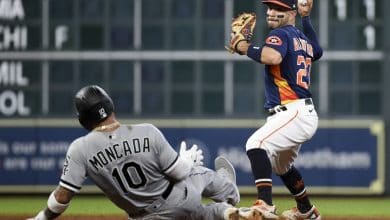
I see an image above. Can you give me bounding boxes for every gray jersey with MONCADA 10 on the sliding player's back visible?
[60,124,178,214]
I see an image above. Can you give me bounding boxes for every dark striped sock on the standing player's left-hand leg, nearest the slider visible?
[247,148,272,205]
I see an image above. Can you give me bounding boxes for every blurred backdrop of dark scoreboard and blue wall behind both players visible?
[0,0,390,195]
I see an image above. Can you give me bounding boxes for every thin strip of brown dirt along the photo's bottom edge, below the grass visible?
[0,215,390,220]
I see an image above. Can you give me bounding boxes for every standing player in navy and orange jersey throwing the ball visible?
[237,0,322,220]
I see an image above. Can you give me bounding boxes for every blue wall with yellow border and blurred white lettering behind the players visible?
[0,119,389,195]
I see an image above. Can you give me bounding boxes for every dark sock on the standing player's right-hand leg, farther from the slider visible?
[280,166,312,213]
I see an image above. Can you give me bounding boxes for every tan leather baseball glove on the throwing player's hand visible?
[225,13,256,55]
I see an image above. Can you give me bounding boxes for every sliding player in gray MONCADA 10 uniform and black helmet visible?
[31,85,256,220]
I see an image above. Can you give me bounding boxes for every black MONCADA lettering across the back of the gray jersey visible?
[88,138,150,170]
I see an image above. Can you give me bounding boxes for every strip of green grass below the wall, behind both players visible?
[0,195,390,218]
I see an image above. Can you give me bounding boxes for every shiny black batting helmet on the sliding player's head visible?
[74,85,114,131]
